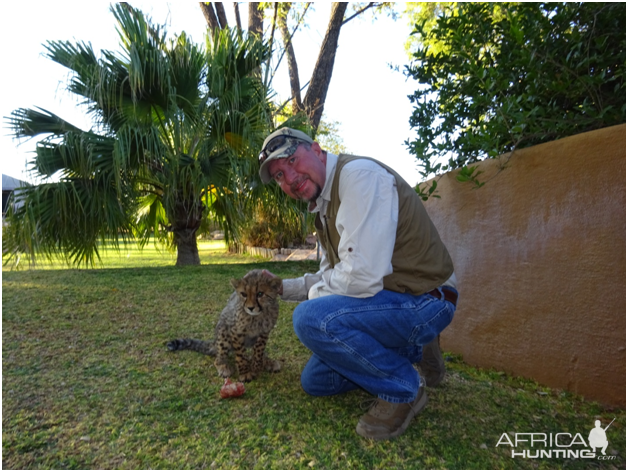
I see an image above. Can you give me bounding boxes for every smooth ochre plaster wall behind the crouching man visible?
[425,125,626,406]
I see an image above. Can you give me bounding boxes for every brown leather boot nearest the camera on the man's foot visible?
[355,387,427,440]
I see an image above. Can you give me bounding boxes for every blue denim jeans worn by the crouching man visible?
[292,290,455,403]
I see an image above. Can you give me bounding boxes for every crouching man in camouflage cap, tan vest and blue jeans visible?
[259,128,458,439]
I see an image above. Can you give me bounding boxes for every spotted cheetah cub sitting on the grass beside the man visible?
[167,270,282,382]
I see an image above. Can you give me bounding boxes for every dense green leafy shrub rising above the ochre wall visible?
[406,3,626,177]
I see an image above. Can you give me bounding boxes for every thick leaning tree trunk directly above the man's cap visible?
[303,2,348,130]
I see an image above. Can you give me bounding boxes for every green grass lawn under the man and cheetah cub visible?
[2,242,626,469]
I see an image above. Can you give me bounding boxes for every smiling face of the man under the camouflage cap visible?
[268,142,327,202]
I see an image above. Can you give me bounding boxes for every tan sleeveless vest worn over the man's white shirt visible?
[315,154,454,295]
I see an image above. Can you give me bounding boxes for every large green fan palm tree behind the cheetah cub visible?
[3,4,271,265]
